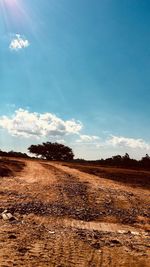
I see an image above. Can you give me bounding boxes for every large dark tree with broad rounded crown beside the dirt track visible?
[28,142,74,161]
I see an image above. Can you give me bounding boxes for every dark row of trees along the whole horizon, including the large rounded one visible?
[0,142,150,169]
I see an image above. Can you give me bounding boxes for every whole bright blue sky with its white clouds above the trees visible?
[0,0,150,159]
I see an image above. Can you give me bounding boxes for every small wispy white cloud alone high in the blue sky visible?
[9,34,30,51]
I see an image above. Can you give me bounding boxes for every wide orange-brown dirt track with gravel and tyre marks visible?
[0,160,150,267]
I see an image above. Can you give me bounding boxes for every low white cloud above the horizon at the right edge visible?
[106,135,150,150]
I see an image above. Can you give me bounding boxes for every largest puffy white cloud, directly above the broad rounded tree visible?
[0,109,82,137]
